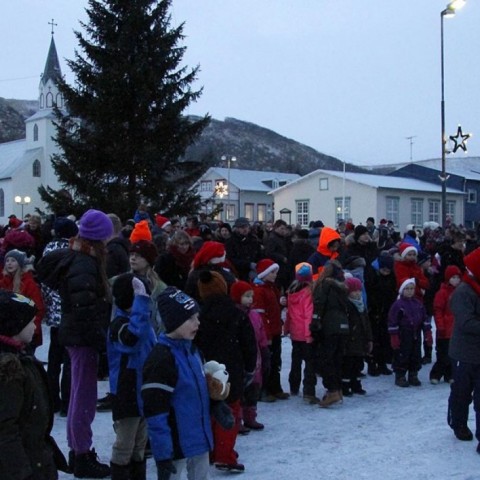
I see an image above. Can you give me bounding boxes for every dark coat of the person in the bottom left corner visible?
[0,341,66,480]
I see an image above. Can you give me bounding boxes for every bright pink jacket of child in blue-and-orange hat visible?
[283,287,313,343]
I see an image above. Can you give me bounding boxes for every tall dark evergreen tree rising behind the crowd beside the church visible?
[40,0,210,219]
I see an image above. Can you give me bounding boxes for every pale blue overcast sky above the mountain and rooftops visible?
[0,0,480,165]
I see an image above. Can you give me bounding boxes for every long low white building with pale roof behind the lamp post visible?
[270,170,465,229]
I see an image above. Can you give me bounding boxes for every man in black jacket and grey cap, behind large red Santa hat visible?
[225,217,262,282]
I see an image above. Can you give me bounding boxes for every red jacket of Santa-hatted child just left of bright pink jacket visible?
[252,282,282,342]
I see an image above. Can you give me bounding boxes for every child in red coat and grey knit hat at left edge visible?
[0,250,45,354]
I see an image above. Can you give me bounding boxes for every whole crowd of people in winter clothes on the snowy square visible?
[0,205,480,480]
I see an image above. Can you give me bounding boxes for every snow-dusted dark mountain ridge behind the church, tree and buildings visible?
[0,97,365,175]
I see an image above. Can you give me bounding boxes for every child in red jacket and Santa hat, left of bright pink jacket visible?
[253,258,290,402]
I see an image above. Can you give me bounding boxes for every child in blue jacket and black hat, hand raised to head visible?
[107,273,156,480]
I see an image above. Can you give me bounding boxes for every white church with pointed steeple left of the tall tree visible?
[0,35,63,225]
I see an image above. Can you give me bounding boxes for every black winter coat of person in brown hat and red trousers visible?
[195,295,257,403]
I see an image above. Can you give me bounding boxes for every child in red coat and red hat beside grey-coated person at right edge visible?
[430,265,462,385]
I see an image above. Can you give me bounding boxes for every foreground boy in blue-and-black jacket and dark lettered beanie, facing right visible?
[142,287,213,480]
